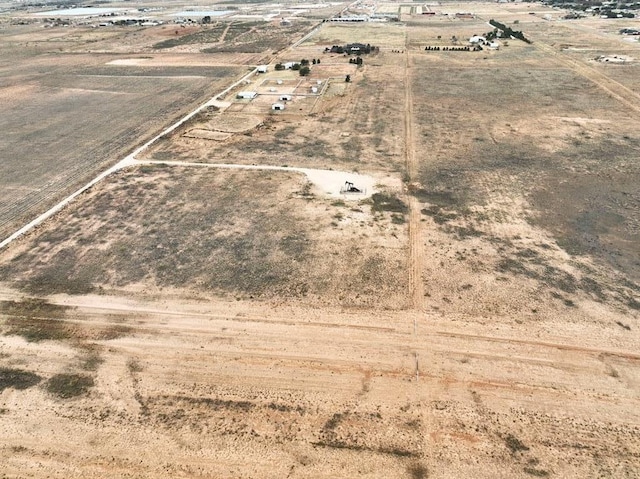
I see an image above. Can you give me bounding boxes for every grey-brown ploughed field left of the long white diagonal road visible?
[0,21,248,239]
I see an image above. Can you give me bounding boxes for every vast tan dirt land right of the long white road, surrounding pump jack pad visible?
[0,3,640,479]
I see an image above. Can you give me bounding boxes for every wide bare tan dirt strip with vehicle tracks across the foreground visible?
[0,289,640,478]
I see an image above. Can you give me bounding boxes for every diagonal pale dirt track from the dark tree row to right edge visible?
[533,40,640,113]
